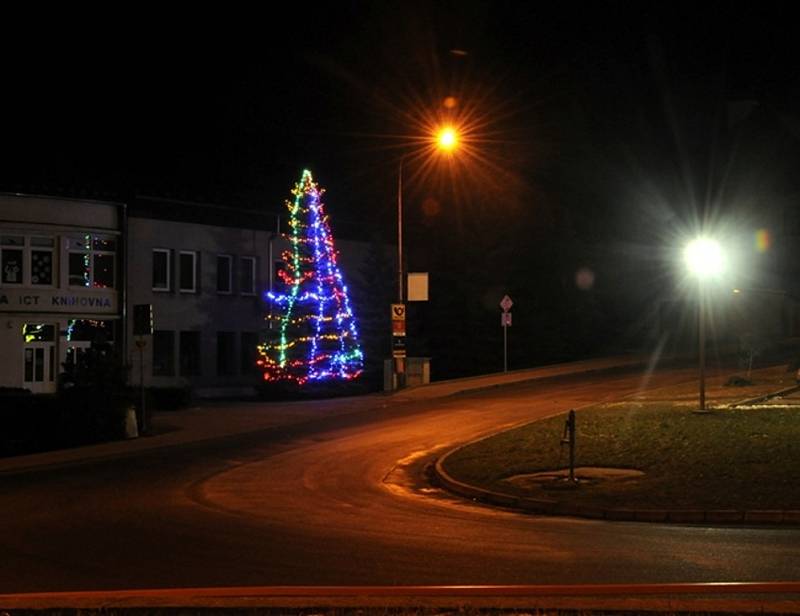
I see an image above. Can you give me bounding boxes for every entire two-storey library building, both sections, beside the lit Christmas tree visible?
[0,194,366,396]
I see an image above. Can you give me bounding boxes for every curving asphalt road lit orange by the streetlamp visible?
[0,370,800,593]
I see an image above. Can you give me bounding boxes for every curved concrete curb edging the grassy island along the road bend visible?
[433,437,800,526]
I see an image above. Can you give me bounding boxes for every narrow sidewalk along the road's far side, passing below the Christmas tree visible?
[0,356,645,475]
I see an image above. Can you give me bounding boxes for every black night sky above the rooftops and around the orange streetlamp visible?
[0,1,797,236]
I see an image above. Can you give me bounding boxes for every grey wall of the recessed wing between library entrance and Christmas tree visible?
[127,217,281,395]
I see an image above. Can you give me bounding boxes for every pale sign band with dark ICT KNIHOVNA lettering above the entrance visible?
[0,289,119,314]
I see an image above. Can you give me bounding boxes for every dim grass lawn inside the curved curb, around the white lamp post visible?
[445,367,800,510]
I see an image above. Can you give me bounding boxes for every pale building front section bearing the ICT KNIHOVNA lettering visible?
[0,194,125,393]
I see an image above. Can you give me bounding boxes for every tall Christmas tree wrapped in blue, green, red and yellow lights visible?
[256,170,364,385]
